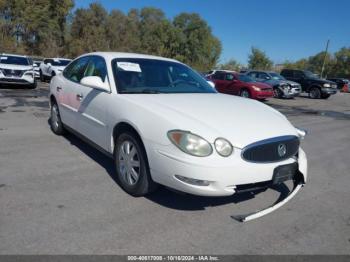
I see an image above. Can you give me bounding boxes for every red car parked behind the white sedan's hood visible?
[207,71,273,100]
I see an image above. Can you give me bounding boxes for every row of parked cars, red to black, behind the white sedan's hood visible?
[204,69,350,100]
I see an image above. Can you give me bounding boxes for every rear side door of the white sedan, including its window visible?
[57,57,89,130]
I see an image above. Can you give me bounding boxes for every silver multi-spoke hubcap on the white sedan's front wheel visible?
[118,140,140,186]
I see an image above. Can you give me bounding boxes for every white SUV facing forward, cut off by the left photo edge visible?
[0,54,36,88]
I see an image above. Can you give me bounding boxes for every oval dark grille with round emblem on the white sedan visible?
[242,136,300,163]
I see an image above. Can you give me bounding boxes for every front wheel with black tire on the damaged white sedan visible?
[114,132,157,197]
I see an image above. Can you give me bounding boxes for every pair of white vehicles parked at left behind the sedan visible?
[0,53,71,88]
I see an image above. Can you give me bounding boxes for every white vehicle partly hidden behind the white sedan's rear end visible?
[39,58,72,82]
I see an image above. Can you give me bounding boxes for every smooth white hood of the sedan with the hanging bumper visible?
[123,93,297,148]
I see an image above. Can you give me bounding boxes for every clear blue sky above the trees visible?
[75,0,350,64]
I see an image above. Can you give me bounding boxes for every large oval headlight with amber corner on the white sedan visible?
[168,130,213,157]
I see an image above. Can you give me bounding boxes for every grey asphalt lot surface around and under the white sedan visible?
[0,84,350,254]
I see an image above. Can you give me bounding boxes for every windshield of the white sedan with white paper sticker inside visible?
[112,58,216,94]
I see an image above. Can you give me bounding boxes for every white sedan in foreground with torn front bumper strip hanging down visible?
[50,52,307,221]
